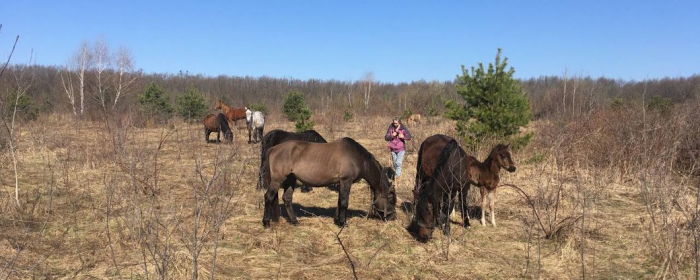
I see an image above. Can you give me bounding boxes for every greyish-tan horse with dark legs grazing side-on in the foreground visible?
[263,138,396,227]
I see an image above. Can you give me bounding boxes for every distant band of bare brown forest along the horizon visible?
[0,65,700,123]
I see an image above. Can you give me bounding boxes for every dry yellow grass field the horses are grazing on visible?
[0,112,693,279]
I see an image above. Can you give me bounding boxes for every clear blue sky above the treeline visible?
[0,0,700,83]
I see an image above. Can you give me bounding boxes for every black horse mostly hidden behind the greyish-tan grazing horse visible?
[258,129,328,192]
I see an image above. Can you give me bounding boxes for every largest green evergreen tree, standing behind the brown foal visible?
[446,49,532,147]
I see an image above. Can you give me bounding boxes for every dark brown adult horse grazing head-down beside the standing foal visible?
[409,135,473,242]
